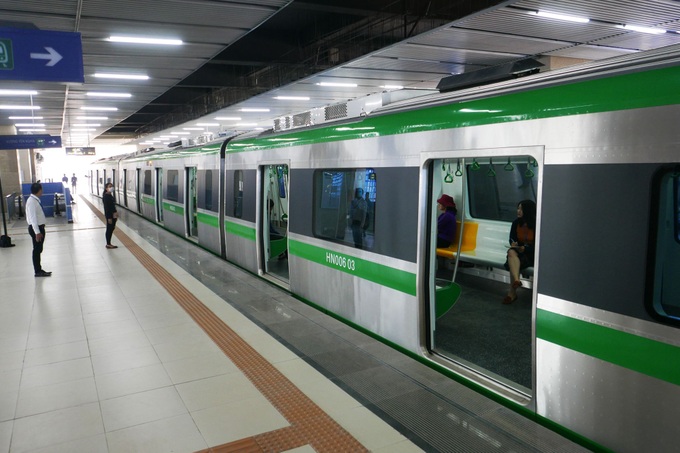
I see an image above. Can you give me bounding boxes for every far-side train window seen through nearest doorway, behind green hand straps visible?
[466,158,538,222]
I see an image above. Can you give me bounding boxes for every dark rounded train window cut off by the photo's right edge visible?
[652,171,680,321]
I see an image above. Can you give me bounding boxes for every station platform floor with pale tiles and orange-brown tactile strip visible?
[0,196,587,453]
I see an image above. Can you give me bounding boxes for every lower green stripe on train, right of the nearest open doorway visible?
[536,309,680,385]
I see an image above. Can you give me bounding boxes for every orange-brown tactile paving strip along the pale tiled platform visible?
[81,197,368,453]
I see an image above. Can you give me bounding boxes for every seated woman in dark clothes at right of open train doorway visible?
[503,200,536,304]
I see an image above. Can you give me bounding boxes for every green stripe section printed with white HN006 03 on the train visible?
[288,240,416,296]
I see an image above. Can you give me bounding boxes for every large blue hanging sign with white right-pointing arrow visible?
[0,27,85,83]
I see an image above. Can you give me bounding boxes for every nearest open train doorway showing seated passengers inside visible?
[426,148,542,401]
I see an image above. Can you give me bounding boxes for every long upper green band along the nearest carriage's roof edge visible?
[227,66,680,152]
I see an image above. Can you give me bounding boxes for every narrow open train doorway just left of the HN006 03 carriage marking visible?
[259,164,289,283]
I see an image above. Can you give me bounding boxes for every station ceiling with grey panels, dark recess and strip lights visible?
[0,0,680,146]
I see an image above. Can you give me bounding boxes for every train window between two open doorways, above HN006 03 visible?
[313,168,376,250]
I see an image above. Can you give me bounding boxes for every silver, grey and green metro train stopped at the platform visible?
[90,47,680,452]
